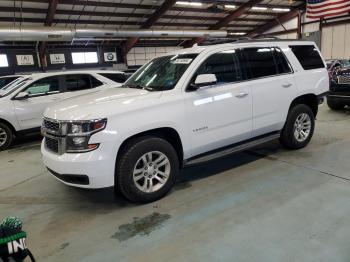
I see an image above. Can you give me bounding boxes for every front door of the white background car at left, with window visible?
[13,76,62,130]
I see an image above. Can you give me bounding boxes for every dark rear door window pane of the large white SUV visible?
[242,47,278,78]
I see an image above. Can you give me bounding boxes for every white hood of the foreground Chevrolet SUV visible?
[44,87,161,120]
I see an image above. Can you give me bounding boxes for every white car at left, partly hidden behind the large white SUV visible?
[0,70,126,151]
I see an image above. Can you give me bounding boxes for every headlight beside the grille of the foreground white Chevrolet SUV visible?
[66,119,107,153]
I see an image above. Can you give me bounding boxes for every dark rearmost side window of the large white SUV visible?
[289,45,325,70]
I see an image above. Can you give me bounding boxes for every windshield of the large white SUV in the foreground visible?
[124,54,197,91]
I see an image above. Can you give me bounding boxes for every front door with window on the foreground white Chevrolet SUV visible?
[184,50,252,156]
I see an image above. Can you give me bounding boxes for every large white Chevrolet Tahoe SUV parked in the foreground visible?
[41,40,329,202]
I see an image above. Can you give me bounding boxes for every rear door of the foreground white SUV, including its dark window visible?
[242,47,297,137]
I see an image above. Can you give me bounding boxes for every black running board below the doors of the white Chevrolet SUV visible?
[184,133,280,166]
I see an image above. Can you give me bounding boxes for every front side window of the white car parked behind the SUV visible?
[24,76,59,96]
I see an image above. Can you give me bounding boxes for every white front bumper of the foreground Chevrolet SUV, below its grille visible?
[41,136,117,189]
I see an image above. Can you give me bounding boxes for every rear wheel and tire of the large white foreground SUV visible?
[280,104,315,149]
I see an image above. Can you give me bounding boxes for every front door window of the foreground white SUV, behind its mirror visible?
[193,50,243,84]
